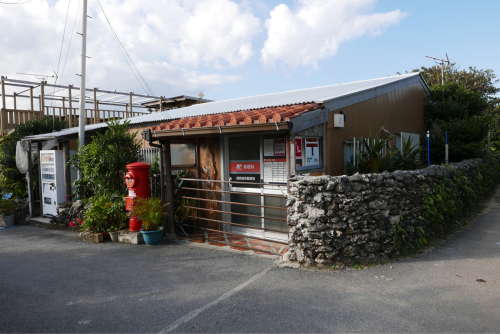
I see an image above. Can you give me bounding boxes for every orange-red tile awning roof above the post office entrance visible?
[150,103,322,131]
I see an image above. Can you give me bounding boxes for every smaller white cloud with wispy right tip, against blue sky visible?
[261,0,406,70]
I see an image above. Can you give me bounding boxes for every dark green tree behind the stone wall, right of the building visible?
[414,64,500,163]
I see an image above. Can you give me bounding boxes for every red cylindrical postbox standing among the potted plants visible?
[125,162,151,231]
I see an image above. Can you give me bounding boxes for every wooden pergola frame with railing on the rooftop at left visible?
[0,76,166,136]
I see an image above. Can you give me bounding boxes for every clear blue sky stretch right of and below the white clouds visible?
[219,0,500,99]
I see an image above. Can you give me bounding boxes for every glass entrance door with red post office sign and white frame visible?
[225,135,288,240]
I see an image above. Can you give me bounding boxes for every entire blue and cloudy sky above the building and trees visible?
[0,0,500,105]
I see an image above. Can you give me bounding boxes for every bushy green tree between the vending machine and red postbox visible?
[69,121,140,197]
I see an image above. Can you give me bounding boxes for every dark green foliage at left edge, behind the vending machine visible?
[0,116,68,197]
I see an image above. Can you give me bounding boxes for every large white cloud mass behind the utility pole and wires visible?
[0,0,261,98]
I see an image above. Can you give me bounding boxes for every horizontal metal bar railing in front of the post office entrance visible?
[177,178,288,255]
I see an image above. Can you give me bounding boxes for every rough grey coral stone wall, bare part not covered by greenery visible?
[287,159,483,265]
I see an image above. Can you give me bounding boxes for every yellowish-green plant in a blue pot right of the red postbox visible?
[131,197,168,245]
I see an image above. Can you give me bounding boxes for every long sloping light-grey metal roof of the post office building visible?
[21,72,428,139]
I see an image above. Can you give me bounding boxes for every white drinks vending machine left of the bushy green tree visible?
[40,150,76,216]
